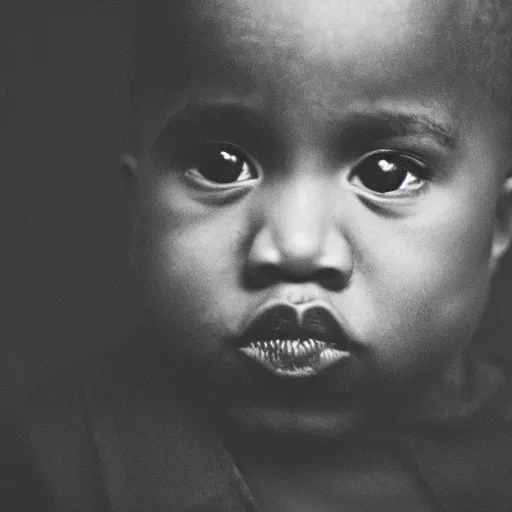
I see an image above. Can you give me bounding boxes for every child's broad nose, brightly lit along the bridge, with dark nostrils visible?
[248,175,353,289]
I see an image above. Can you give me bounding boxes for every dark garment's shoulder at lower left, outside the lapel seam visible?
[0,346,169,511]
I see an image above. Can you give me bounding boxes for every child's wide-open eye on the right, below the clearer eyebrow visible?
[349,151,428,196]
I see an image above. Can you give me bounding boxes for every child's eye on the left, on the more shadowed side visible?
[186,141,259,186]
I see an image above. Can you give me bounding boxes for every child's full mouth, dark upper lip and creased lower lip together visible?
[236,302,358,378]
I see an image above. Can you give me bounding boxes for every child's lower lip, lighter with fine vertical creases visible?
[239,339,350,378]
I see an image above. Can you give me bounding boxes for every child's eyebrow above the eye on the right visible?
[340,110,460,150]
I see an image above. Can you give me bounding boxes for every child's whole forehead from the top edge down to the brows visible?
[136,0,480,142]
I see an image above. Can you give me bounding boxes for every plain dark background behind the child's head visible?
[4,0,512,398]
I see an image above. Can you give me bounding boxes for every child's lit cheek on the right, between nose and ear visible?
[352,186,493,372]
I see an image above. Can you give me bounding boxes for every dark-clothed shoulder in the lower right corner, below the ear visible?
[405,387,512,512]
